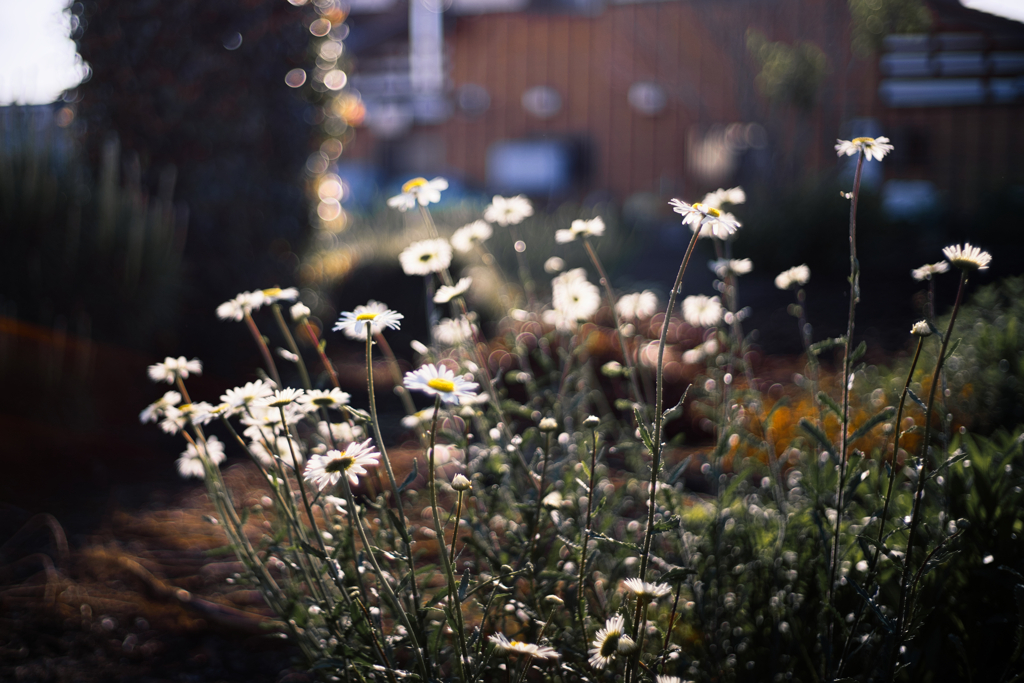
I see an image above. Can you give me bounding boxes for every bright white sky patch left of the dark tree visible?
[0,0,84,104]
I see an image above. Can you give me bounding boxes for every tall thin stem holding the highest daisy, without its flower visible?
[822,151,864,675]
